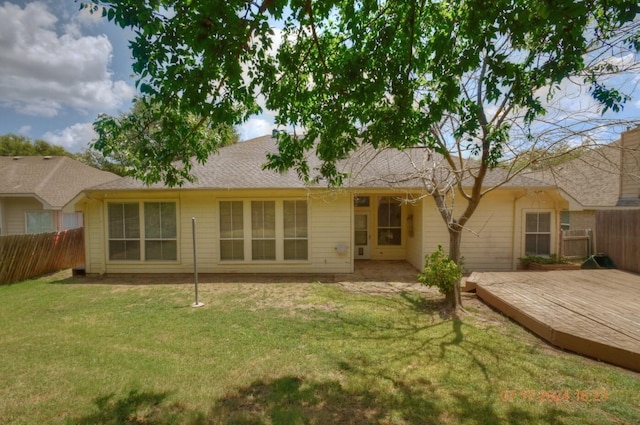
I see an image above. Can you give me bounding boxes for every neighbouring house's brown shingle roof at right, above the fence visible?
[527,142,621,209]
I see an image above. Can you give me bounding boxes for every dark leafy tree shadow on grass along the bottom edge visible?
[67,374,567,425]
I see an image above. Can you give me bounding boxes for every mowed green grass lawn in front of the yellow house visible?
[0,272,640,425]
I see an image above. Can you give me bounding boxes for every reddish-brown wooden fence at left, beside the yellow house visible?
[0,228,84,284]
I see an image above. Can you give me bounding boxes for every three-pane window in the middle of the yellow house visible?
[219,200,309,261]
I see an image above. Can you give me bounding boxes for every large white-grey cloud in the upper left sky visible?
[0,2,135,117]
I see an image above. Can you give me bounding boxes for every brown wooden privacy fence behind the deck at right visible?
[596,210,640,273]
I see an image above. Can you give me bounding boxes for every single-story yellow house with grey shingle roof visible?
[72,136,570,274]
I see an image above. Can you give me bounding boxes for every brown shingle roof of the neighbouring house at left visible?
[0,156,120,209]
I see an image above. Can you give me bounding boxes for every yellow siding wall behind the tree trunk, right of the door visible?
[423,190,566,273]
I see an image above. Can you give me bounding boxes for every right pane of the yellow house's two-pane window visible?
[144,202,178,261]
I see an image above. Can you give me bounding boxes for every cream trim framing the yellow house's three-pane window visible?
[216,197,312,265]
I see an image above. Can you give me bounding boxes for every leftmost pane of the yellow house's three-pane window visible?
[220,201,244,260]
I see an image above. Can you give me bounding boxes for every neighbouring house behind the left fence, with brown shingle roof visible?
[0,156,119,235]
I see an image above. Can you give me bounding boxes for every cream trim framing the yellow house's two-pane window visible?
[104,198,182,265]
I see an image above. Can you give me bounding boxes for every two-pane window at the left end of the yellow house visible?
[107,202,178,261]
